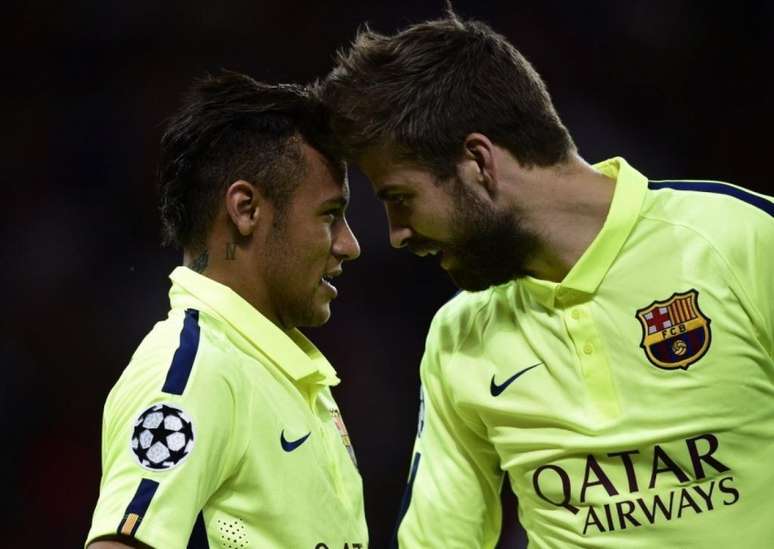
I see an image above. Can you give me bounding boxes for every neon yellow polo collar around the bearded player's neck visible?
[524,157,648,308]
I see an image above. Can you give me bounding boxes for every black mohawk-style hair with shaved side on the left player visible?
[159,71,341,249]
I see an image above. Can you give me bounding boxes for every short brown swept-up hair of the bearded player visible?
[319,13,575,178]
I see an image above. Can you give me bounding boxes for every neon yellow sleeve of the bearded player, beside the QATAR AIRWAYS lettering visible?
[397,317,503,549]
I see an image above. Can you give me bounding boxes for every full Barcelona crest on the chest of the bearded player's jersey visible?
[637,289,712,370]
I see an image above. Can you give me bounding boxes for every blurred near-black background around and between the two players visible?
[0,0,774,548]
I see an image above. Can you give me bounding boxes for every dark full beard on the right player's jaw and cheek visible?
[444,178,537,292]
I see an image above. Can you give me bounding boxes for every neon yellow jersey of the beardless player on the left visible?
[87,267,368,549]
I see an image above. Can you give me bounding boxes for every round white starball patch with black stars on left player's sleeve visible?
[130,404,194,471]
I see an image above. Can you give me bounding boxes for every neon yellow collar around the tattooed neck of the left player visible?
[169,267,340,385]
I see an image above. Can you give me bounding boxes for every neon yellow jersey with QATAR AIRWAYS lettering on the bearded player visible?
[398,158,774,549]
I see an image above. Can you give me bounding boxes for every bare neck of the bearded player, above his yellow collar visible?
[519,155,615,282]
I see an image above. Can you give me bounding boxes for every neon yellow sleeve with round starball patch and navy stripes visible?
[87,317,249,549]
